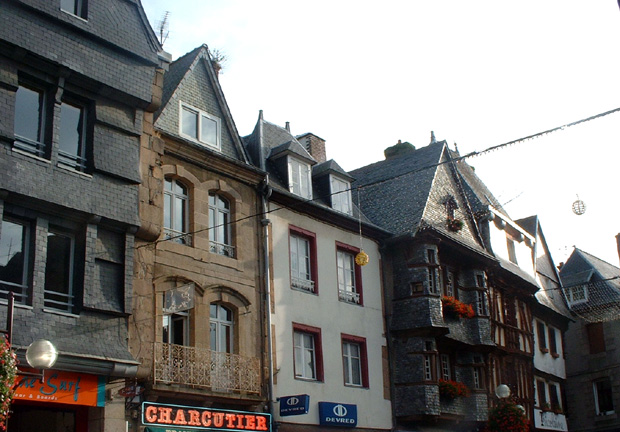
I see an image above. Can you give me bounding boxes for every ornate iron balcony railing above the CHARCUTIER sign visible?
[153,342,261,394]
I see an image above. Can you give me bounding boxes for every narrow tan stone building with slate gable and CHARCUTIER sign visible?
[127,45,271,430]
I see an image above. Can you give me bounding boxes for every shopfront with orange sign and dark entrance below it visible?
[8,370,105,432]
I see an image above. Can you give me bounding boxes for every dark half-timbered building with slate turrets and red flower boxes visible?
[349,137,538,431]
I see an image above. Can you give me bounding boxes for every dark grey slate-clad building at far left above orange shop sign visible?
[0,0,163,431]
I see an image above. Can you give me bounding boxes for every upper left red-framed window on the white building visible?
[289,225,319,294]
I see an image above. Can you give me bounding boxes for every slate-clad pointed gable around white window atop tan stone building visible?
[155,45,249,163]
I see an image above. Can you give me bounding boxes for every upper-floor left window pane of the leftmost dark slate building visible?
[15,86,43,141]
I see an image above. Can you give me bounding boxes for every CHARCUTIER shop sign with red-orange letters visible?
[142,402,271,432]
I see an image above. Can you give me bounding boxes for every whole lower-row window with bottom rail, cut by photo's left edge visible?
[0,217,31,304]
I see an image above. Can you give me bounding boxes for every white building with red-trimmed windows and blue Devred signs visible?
[244,112,392,432]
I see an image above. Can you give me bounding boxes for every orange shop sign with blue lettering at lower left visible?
[13,370,105,407]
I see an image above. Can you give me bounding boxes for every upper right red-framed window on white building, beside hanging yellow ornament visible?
[336,242,364,305]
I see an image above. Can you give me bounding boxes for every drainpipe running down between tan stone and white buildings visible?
[261,174,277,430]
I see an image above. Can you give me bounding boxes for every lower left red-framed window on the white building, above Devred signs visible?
[293,323,323,381]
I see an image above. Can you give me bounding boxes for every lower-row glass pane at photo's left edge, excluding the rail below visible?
[0,219,28,285]
